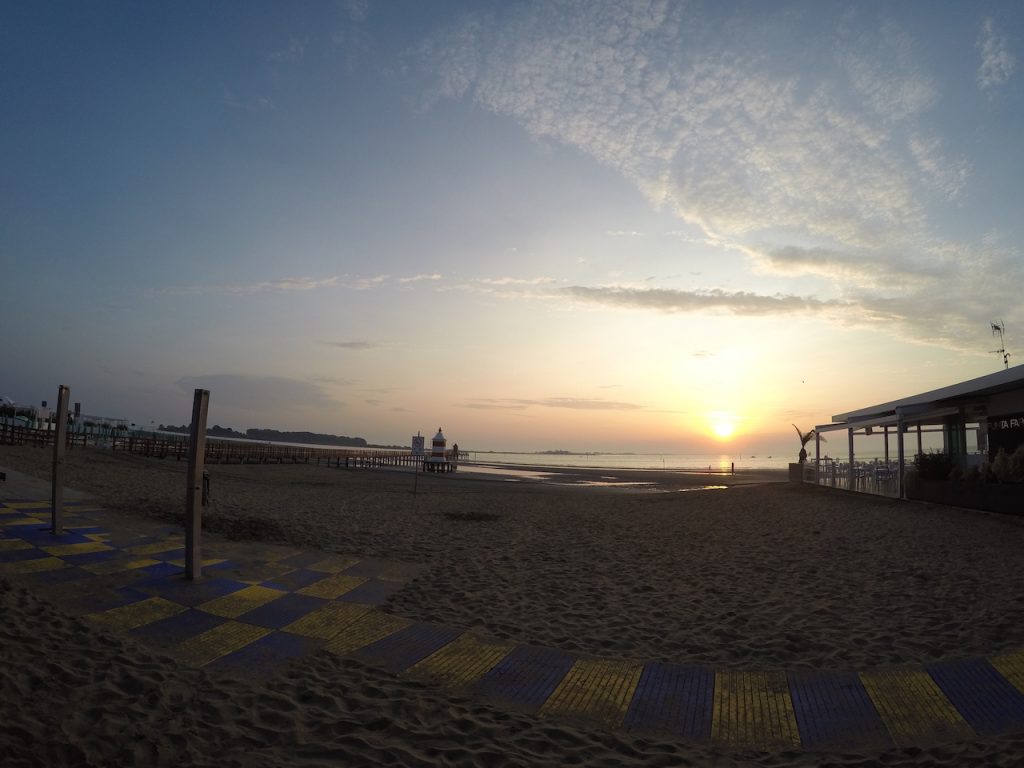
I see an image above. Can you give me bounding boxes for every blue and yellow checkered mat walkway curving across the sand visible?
[6,501,1024,752]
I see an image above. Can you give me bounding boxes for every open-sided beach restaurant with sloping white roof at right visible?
[803,366,1024,512]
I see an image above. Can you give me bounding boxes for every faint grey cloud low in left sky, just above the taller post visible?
[175,374,341,414]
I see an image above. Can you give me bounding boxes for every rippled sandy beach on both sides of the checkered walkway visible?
[6,446,1024,766]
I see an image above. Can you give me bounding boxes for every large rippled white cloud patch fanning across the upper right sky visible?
[417,2,936,245]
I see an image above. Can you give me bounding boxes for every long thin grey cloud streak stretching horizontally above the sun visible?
[562,286,844,315]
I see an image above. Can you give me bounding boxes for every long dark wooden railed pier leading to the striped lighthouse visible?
[0,424,465,472]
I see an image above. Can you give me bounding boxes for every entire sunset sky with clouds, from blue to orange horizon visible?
[0,0,1024,454]
